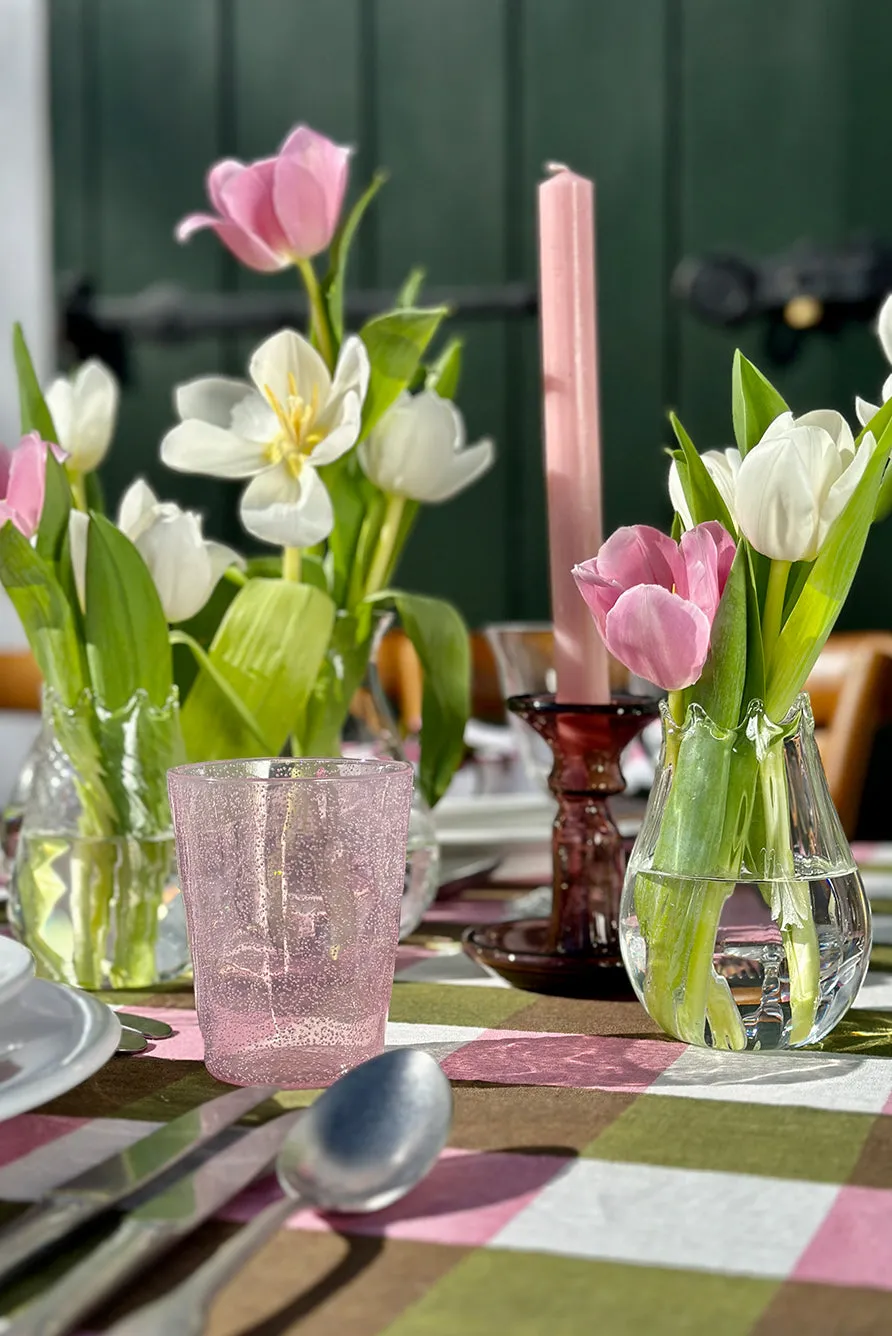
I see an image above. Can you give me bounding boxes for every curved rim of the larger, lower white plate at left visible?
[0,978,122,1124]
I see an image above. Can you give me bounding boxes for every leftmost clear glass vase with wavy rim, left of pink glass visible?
[9,688,190,989]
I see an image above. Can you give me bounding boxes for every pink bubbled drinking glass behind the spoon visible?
[167,759,413,1089]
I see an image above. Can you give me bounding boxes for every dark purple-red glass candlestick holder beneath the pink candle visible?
[463,695,658,998]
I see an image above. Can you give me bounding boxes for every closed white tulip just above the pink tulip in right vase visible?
[734,410,876,561]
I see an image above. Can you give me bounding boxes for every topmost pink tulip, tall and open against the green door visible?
[176,126,351,274]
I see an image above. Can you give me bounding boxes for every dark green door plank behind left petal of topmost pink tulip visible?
[89,0,224,521]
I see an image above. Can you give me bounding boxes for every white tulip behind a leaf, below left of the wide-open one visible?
[68,478,244,621]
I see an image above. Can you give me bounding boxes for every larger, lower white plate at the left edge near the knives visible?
[0,979,120,1120]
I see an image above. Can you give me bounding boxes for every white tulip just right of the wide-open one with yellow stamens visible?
[359,390,495,502]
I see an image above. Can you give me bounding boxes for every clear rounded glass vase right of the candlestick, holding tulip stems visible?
[620,695,871,1051]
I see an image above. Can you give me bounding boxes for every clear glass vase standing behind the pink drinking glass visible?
[304,609,439,939]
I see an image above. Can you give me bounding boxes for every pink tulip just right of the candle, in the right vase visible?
[573,521,736,691]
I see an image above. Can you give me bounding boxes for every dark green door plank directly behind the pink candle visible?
[523,0,668,616]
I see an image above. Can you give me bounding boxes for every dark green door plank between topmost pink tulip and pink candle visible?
[375,0,507,623]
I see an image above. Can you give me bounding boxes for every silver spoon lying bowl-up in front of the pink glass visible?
[105,1049,453,1336]
